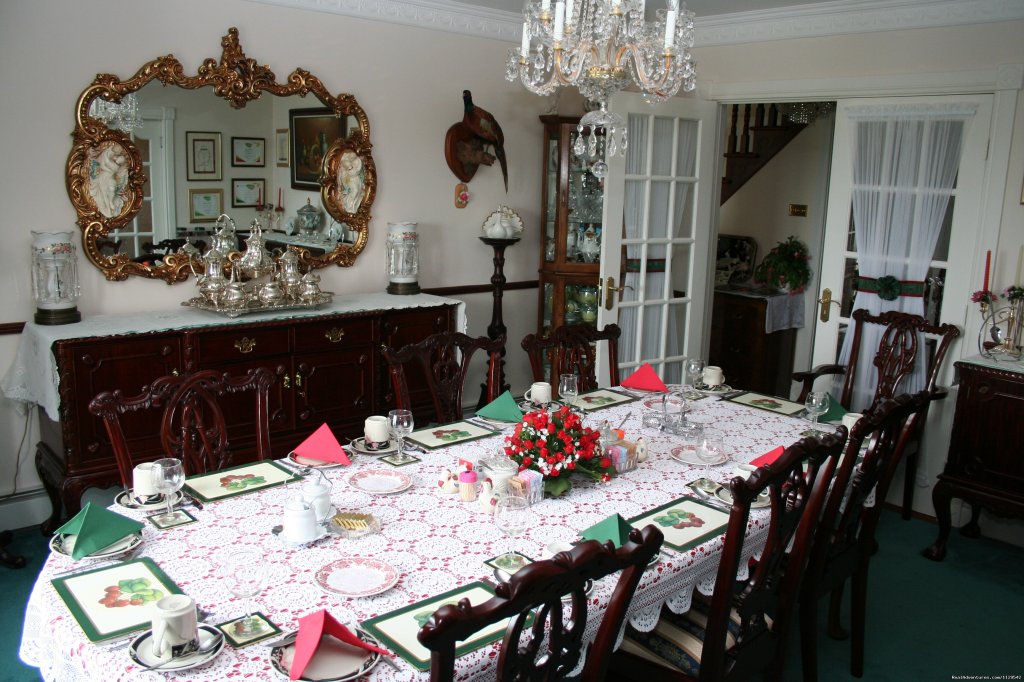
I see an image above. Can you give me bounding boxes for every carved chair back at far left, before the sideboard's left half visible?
[89,368,276,487]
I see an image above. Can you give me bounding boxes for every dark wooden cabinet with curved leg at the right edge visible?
[925,360,1024,561]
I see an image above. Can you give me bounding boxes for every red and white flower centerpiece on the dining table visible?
[505,407,615,497]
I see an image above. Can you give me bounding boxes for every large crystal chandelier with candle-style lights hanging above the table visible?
[505,0,696,178]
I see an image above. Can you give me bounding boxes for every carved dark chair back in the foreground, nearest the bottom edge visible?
[418,525,664,682]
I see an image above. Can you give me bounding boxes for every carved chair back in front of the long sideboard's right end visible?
[381,332,505,424]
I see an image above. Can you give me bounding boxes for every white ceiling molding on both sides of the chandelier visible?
[248,0,1024,47]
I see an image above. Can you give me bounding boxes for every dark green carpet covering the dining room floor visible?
[0,512,1024,682]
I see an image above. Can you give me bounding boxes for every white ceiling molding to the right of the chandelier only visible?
[694,0,1024,47]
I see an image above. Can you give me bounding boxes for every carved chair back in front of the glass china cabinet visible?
[521,325,622,392]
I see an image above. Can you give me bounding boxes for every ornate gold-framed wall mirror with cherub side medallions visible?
[67,28,377,284]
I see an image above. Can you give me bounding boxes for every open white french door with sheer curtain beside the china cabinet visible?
[597,93,721,385]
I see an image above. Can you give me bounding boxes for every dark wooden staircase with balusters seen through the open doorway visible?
[721,100,807,204]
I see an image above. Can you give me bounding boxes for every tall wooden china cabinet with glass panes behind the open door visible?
[538,116,604,332]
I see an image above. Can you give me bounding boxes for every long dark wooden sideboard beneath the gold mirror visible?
[29,297,461,530]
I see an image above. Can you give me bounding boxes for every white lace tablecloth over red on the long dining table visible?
[19,397,823,682]
